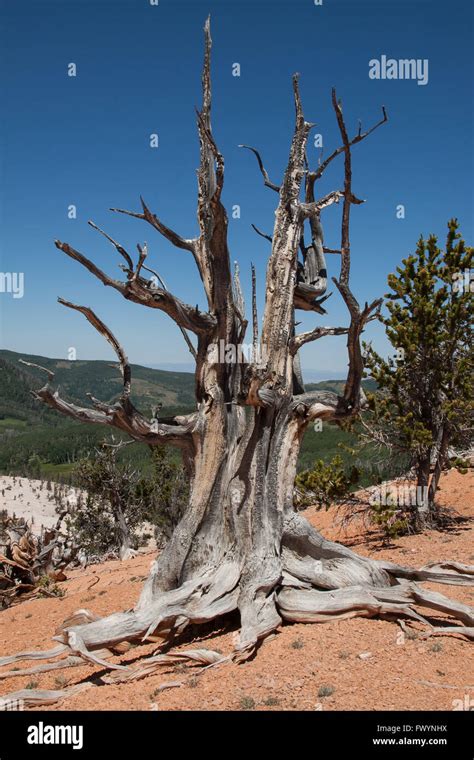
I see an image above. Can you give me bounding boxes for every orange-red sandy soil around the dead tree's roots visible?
[0,471,474,710]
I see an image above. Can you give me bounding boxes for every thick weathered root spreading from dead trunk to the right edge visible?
[278,514,474,638]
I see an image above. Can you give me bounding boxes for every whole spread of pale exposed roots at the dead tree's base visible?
[0,513,474,706]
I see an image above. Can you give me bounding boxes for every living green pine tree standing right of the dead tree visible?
[366,219,474,527]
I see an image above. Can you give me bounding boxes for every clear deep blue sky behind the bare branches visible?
[0,0,473,376]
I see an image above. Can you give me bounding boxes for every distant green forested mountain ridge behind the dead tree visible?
[0,349,378,477]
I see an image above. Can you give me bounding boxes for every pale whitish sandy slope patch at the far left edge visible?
[0,475,78,533]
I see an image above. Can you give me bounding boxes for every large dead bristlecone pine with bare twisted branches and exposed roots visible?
[4,21,474,700]
